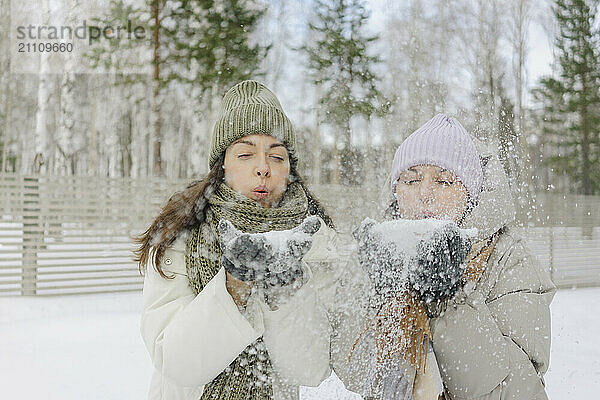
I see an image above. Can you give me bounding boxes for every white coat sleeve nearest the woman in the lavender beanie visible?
[274,222,368,390]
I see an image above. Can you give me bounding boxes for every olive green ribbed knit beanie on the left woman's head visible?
[208,80,296,168]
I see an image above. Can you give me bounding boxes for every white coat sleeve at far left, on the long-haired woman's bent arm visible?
[141,244,264,387]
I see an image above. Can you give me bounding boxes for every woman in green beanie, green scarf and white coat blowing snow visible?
[136,81,339,400]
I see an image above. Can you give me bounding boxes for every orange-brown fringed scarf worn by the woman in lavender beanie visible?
[355,234,498,371]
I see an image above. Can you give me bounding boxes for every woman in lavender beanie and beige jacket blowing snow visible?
[355,114,555,400]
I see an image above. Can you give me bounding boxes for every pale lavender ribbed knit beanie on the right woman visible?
[390,114,483,200]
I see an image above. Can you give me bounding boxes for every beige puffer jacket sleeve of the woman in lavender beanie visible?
[431,238,555,399]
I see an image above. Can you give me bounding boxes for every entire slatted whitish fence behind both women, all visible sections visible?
[0,174,600,295]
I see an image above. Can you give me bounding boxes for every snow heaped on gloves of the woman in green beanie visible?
[219,216,321,287]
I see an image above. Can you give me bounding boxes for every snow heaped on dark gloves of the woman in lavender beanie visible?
[354,218,477,304]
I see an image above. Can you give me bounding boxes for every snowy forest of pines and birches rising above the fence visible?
[0,0,600,194]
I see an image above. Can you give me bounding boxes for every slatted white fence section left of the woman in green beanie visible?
[0,174,184,295]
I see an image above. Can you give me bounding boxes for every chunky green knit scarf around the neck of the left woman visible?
[185,183,308,400]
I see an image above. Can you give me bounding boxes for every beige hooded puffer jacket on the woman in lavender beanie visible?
[430,143,556,400]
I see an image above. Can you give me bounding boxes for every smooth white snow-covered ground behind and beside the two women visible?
[0,288,600,400]
